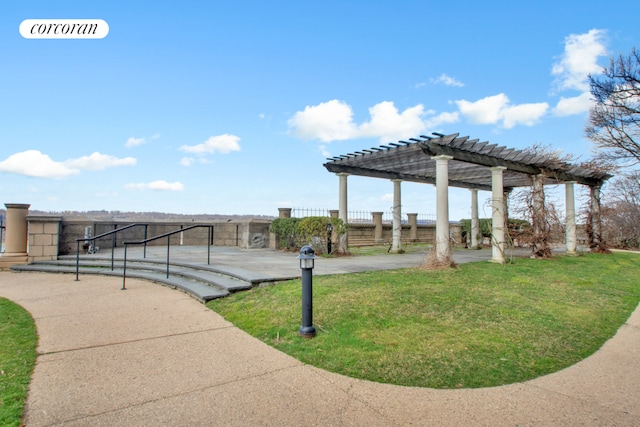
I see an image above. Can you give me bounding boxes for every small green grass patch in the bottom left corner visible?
[0,298,38,426]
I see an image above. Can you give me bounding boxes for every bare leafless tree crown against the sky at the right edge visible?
[585,48,640,164]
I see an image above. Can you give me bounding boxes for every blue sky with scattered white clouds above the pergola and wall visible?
[0,0,640,219]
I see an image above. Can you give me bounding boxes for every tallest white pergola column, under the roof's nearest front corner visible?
[432,155,453,263]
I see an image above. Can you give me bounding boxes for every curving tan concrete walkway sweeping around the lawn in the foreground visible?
[0,252,640,427]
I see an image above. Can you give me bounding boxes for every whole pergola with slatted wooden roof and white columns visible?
[324,133,611,262]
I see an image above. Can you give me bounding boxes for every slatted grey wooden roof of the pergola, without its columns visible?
[324,133,611,191]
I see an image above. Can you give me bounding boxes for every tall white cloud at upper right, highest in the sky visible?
[551,29,607,92]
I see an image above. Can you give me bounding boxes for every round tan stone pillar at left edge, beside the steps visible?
[0,203,31,269]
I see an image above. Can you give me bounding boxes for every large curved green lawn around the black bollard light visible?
[208,253,640,388]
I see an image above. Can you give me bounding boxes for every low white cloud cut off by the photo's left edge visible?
[0,150,79,178]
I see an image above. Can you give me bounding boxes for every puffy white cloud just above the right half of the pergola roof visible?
[454,93,549,129]
